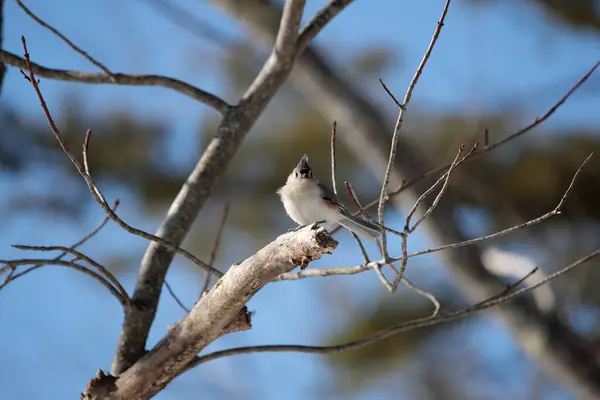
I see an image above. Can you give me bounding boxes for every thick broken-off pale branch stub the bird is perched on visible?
[82,227,337,400]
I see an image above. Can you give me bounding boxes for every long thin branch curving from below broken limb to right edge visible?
[187,250,600,370]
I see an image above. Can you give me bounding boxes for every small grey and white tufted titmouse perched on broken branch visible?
[277,155,381,240]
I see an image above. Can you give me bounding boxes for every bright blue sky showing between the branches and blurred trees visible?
[0,0,600,399]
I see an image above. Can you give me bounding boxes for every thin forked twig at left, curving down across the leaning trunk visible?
[21,36,223,277]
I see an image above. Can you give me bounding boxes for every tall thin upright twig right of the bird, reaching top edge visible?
[377,0,452,261]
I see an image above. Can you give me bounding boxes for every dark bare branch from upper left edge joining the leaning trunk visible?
[0,50,229,115]
